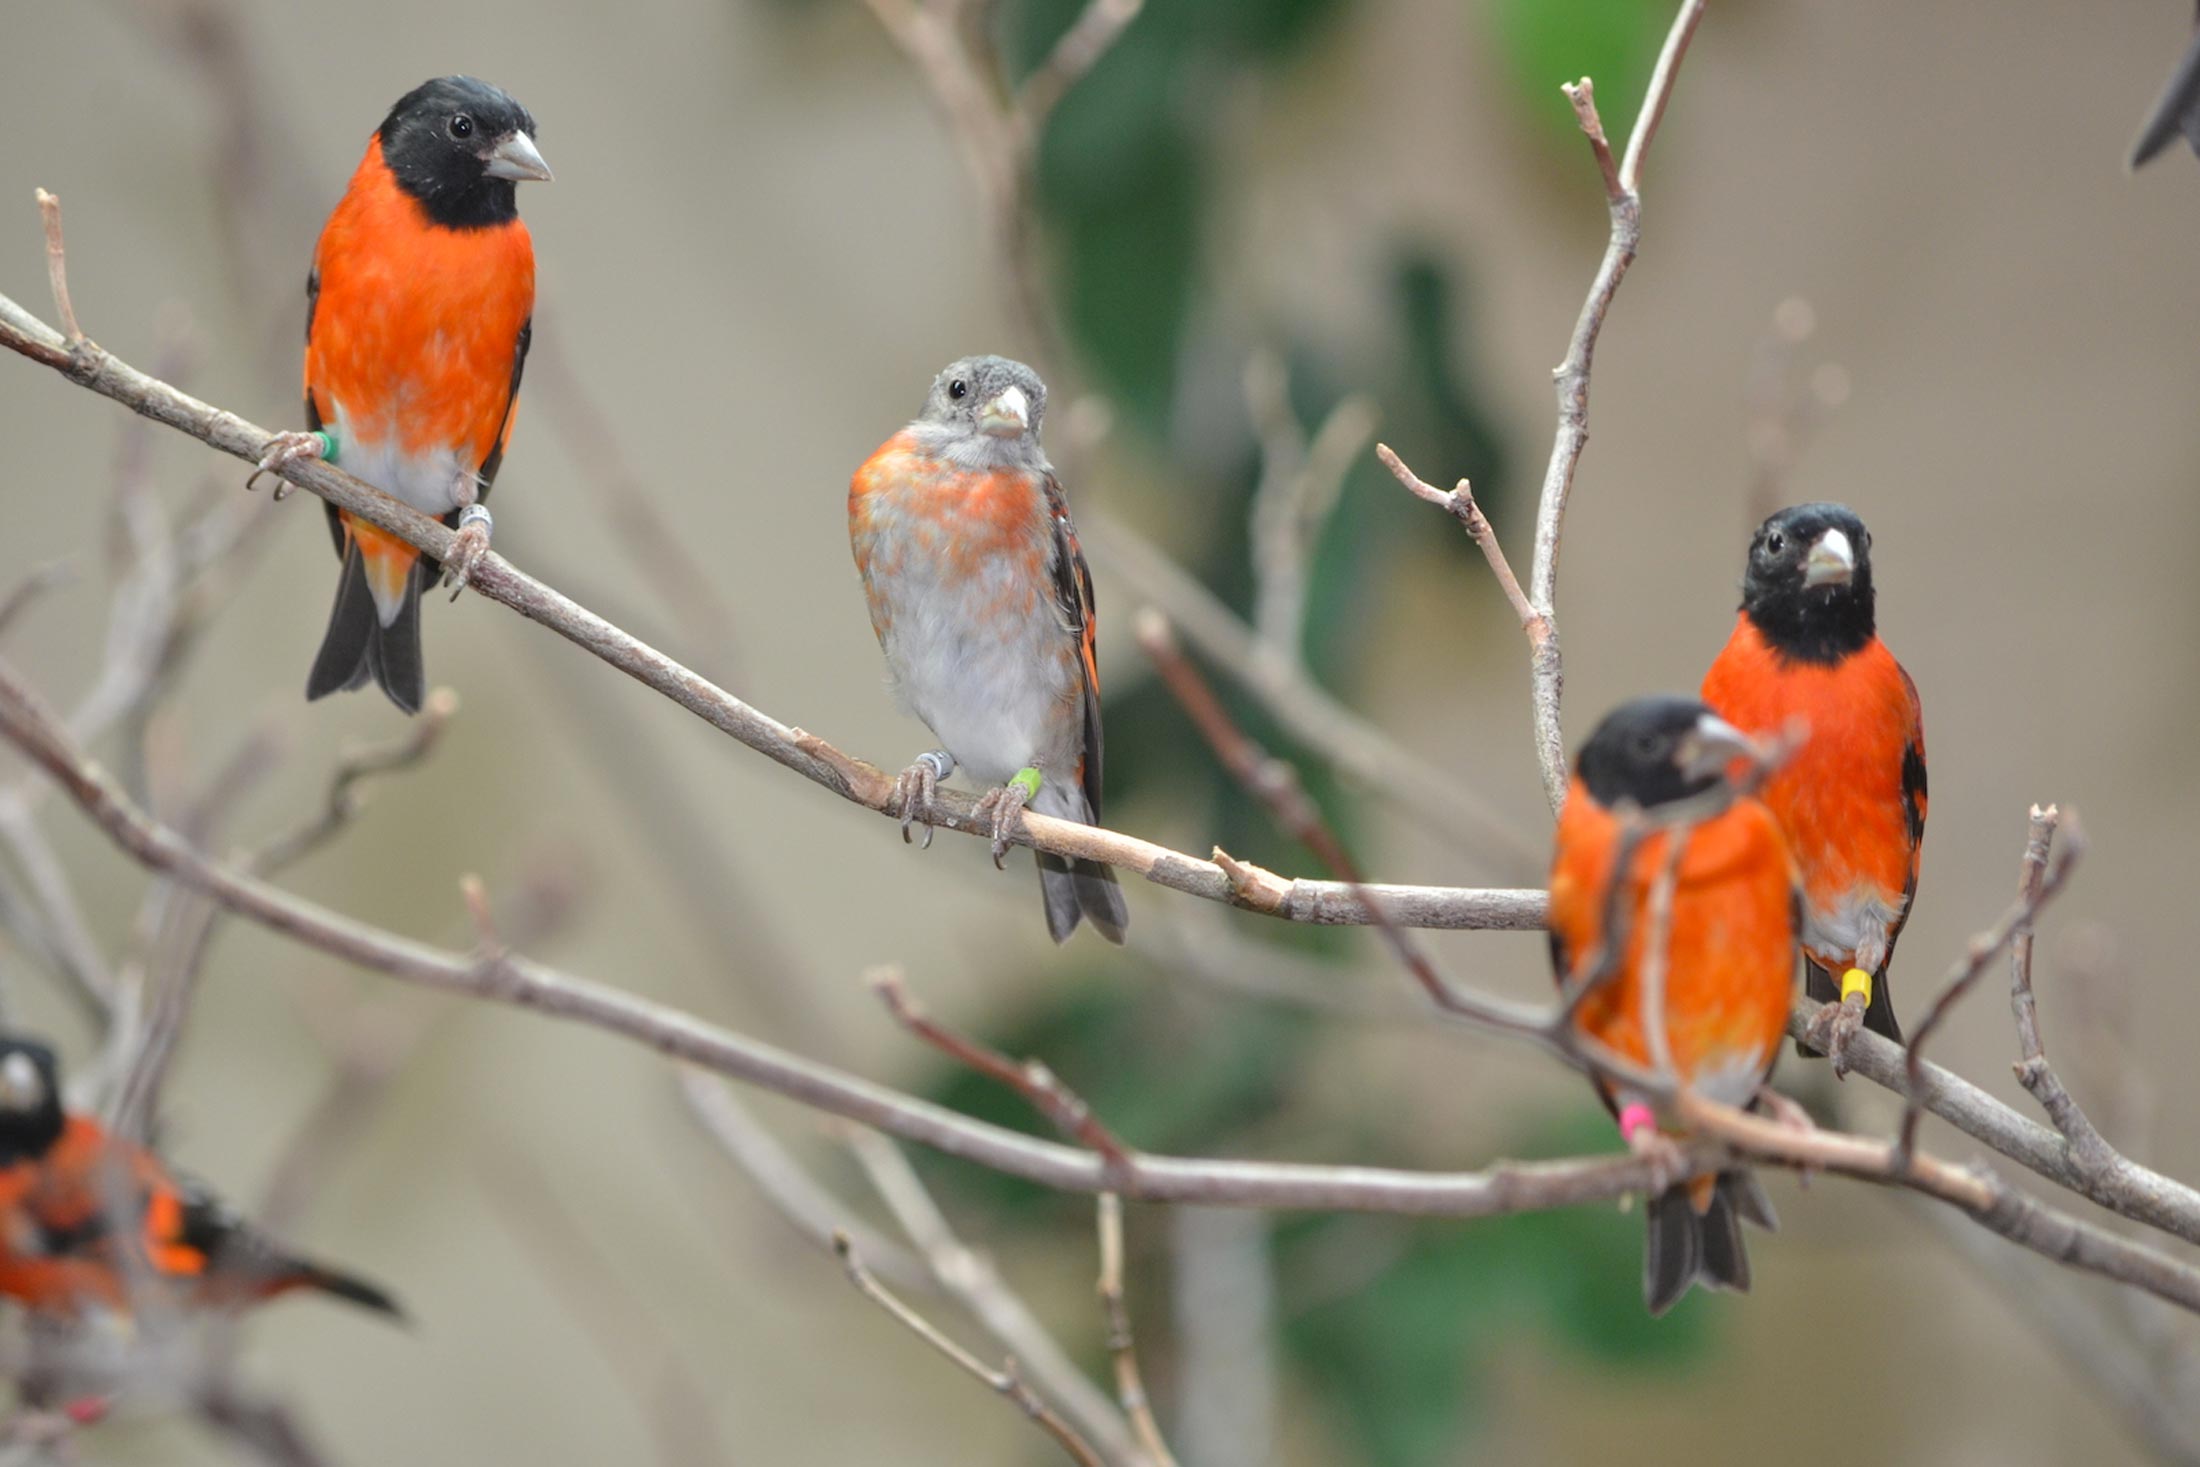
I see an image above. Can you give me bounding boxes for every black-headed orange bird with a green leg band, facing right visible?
[260,77,550,713]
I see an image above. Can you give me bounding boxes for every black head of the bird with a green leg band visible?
[378,77,550,229]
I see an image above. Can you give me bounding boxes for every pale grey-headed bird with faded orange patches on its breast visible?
[847,356,1129,941]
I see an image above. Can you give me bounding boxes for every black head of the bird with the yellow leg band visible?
[1742,504,1872,662]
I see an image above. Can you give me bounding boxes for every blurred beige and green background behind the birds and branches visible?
[0,0,2200,1467]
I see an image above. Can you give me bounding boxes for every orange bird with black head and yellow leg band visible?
[1703,504,1925,1067]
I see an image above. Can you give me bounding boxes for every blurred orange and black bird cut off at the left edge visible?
[0,1036,400,1317]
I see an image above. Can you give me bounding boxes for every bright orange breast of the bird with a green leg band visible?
[306,139,535,466]
